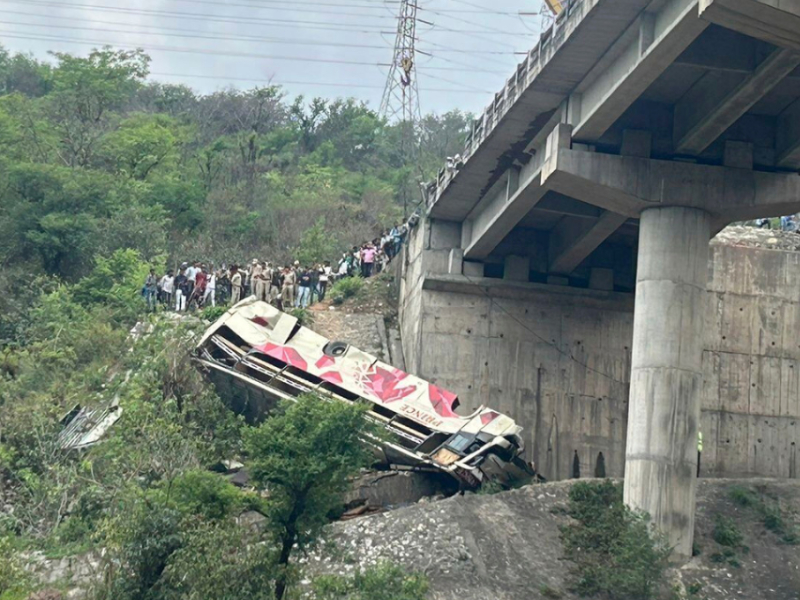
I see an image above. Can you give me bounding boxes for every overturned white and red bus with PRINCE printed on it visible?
[195,298,535,488]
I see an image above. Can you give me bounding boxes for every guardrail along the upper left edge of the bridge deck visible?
[427,0,586,208]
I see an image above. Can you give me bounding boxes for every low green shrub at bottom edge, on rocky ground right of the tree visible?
[313,563,428,600]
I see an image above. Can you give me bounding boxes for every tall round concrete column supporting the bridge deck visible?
[625,207,711,558]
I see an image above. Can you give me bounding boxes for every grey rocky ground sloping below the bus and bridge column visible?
[305,479,800,600]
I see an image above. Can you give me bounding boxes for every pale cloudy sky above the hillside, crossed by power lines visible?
[0,0,542,113]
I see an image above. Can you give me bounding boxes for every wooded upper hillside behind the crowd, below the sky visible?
[0,48,469,341]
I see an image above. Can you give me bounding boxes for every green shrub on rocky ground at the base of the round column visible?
[561,481,671,600]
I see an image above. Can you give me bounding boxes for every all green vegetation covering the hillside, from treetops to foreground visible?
[0,48,468,600]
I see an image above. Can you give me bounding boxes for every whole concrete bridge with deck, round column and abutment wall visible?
[410,0,800,568]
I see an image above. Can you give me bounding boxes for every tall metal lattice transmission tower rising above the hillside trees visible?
[380,0,422,126]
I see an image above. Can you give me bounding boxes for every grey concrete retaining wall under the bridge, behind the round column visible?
[400,222,800,479]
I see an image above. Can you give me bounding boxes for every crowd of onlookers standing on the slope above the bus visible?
[142,214,419,312]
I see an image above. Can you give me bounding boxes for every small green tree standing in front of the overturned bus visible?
[245,395,370,600]
